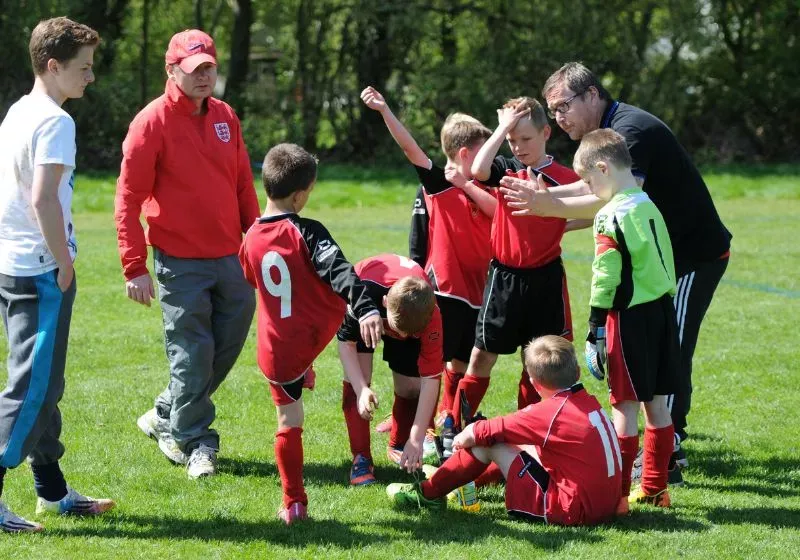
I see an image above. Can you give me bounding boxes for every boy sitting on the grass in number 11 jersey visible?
[386,336,627,525]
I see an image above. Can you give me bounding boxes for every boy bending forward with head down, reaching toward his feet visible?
[336,253,444,485]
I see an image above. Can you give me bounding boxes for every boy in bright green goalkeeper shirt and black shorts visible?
[574,129,680,507]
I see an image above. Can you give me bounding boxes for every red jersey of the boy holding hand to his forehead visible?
[489,156,580,268]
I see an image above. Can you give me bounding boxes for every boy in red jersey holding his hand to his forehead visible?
[453,97,578,423]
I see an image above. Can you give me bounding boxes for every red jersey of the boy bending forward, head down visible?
[355,253,444,377]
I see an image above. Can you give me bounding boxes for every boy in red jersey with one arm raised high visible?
[361,87,497,426]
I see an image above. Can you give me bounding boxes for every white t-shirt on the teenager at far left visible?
[0,92,78,276]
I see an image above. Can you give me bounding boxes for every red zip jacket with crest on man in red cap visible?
[114,80,260,280]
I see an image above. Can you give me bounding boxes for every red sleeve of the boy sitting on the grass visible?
[473,405,550,447]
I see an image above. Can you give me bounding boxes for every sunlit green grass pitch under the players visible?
[0,164,800,560]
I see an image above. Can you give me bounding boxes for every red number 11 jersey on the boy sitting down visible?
[474,383,622,525]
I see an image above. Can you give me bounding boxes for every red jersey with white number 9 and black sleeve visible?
[239,214,378,384]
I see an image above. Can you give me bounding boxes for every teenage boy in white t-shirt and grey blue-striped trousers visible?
[0,17,114,533]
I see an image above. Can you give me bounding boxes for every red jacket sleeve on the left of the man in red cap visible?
[114,113,162,280]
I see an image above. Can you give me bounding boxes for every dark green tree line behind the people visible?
[0,0,800,169]
